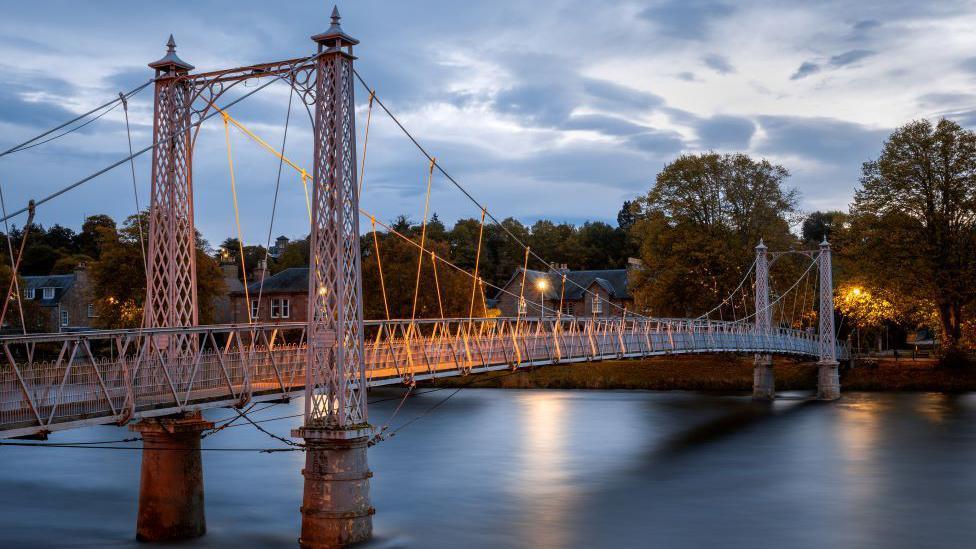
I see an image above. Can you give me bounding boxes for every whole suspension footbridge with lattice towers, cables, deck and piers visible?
[0,10,848,547]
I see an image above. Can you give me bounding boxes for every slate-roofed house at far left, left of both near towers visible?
[21,264,96,332]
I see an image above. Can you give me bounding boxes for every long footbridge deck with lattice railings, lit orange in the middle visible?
[0,317,846,438]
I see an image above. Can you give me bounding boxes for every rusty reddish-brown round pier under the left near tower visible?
[129,412,213,541]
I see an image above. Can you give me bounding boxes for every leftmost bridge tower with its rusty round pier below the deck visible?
[130,35,213,541]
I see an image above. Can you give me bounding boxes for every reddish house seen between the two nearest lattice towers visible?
[228,261,308,324]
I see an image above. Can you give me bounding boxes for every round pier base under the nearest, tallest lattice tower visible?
[293,426,375,549]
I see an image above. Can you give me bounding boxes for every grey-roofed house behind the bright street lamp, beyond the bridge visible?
[495,262,637,317]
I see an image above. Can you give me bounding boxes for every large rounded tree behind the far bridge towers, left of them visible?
[630,153,796,316]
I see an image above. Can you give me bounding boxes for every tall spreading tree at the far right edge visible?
[851,119,976,358]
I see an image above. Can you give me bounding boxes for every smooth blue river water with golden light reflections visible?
[0,389,976,549]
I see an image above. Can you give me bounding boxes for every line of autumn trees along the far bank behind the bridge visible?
[0,119,976,362]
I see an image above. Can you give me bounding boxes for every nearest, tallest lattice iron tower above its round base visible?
[305,10,367,430]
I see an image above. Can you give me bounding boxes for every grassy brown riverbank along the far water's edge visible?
[430,355,976,393]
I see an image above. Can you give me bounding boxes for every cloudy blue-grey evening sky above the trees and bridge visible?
[0,0,976,243]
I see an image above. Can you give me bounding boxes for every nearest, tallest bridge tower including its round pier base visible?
[293,8,374,548]
